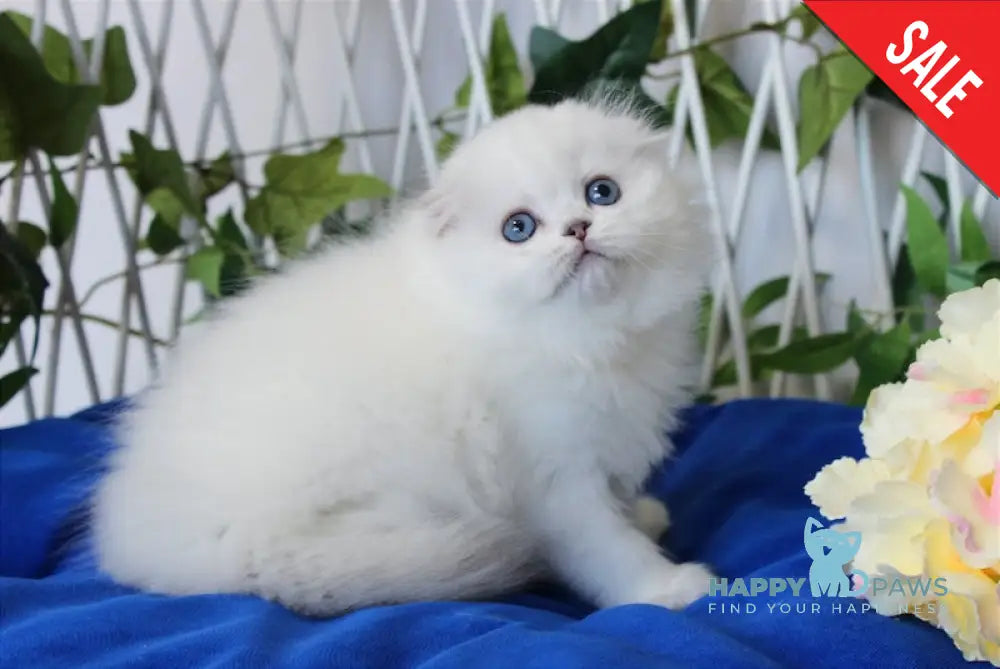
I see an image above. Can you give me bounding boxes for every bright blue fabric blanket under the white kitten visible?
[0,400,985,669]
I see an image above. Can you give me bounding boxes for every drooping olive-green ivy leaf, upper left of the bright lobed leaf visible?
[122,130,204,228]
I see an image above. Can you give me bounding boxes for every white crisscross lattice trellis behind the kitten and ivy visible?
[0,0,1000,422]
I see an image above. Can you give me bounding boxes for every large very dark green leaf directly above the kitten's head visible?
[528,1,660,104]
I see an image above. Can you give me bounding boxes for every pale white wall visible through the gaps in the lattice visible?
[0,0,1000,424]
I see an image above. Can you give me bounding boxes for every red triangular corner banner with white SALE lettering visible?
[804,0,1000,195]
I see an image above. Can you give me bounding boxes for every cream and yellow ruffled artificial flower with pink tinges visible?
[805,279,1000,666]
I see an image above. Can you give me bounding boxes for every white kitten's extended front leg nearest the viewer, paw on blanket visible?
[531,476,712,608]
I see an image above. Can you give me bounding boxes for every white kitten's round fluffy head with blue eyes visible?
[412,101,711,348]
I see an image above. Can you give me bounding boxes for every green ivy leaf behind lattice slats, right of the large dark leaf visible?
[667,47,781,148]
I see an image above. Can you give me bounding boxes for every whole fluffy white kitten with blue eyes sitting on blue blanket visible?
[94,96,710,614]
